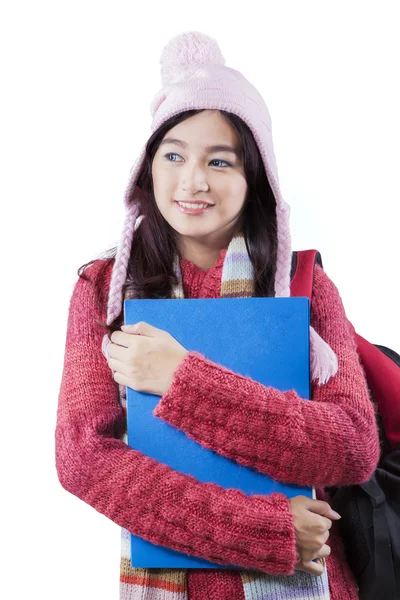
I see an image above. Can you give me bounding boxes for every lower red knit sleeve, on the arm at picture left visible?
[55,261,296,575]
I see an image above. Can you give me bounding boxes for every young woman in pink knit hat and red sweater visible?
[56,32,379,600]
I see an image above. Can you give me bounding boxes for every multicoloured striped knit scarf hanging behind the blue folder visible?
[119,233,332,600]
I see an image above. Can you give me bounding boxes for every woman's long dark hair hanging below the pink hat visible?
[78,109,278,335]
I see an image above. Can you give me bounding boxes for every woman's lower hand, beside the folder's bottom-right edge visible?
[289,496,340,575]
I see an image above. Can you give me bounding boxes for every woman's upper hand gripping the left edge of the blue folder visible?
[107,321,189,396]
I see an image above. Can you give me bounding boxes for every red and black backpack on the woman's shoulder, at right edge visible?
[291,250,400,600]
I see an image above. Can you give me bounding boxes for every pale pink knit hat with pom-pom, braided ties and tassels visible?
[102,31,338,384]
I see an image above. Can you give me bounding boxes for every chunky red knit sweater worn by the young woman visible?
[56,250,379,600]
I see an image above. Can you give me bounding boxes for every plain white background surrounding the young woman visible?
[0,0,400,600]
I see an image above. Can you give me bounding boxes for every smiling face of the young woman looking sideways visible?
[152,110,247,248]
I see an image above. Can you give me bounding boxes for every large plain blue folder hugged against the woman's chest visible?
[124,297,314,569]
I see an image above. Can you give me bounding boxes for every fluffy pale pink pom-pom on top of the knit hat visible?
[160,31,225,87]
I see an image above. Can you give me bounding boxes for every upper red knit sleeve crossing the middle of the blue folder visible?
[153,265,380,487]
